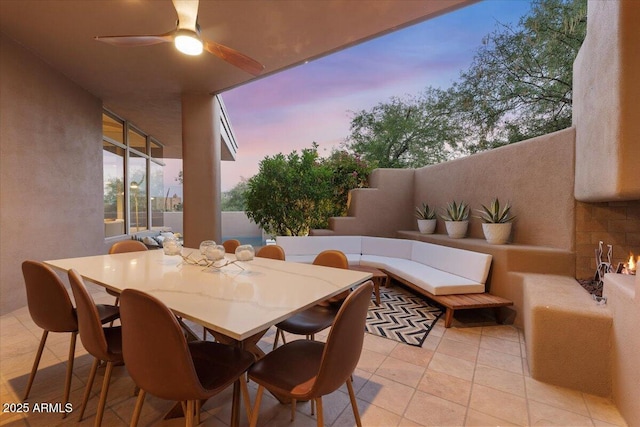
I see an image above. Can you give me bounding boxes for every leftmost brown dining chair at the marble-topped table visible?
[22,260,120,418]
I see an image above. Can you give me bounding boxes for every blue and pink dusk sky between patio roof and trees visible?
[165,0,530,191]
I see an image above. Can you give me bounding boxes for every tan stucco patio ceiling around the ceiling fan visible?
[0,0,477,157]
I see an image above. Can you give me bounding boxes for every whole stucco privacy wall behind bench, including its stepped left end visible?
[330,129,575,251]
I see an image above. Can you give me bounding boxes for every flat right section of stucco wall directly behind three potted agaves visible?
[412,129,575,250]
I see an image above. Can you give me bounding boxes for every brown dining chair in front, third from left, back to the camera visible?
[121,289,255,426]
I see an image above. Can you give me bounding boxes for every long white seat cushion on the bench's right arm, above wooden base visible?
[360,255,484,295]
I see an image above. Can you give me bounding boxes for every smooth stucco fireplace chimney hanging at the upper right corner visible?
[573,0,640,202]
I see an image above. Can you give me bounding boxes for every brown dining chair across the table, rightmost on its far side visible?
[273,250,349,349]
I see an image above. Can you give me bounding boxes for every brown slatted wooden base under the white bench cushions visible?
[386,272,513,328]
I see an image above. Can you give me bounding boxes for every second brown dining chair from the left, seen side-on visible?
[68,269,124,427]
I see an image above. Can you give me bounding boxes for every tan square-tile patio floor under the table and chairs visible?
[0,289,626,427]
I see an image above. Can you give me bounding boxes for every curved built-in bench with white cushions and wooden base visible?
[276,236,512,327]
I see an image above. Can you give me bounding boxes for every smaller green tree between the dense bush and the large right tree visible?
[344,87,458,168]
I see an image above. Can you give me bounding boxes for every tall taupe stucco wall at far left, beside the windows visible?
[0,35,105,314]
